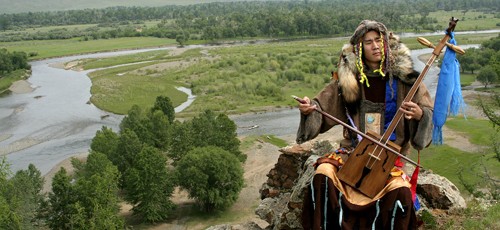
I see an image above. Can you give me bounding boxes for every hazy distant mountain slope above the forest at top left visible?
[0,0,292,14]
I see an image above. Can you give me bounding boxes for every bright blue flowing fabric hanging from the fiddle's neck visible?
[432,32,465,145]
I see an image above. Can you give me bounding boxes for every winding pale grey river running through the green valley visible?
[0,31,492,175]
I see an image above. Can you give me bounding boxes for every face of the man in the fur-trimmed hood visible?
[363,30,382,69]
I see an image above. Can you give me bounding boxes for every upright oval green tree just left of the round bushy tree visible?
[124,146,175,222]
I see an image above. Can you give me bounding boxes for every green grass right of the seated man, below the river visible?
[412,117,500,230]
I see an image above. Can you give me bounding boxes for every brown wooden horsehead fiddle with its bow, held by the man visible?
[292,17,463,198]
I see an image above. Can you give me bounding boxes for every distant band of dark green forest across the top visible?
[0,0,500,44]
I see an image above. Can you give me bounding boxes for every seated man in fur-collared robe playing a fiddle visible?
[296,20,433,229]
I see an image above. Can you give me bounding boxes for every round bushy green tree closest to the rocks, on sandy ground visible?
[176,146,244,212]
